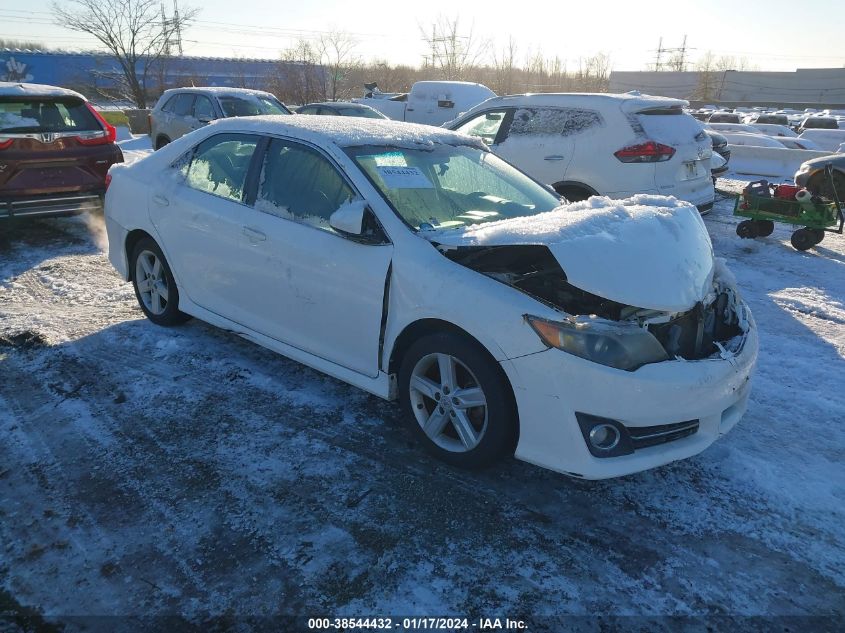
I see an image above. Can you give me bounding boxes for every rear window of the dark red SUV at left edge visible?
[0,97,103,134]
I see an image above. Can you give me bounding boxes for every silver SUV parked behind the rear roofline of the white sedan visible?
[150,88,291,149]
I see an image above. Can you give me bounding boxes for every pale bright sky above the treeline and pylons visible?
[0,0,845,70]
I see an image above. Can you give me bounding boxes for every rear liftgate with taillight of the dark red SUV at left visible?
[0,97,118,198]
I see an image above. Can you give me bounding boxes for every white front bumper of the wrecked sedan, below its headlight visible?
[502,321,757,479]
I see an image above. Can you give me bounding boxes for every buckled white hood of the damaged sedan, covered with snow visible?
[428,195,713,312]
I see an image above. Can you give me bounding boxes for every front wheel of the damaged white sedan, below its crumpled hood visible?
[399,333,517,468]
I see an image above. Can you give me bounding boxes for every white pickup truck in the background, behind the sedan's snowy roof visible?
[353,81,496,125]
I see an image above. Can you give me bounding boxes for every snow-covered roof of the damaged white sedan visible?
[204,115,484,149]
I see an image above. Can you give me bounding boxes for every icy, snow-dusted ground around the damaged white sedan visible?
[0,172,845,631]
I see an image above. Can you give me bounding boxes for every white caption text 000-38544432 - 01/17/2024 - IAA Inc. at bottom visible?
[308,617,528,631]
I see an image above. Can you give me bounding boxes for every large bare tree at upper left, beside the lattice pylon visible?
[52,0,198,108]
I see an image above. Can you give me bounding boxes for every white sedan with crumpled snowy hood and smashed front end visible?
[105,117,757,479]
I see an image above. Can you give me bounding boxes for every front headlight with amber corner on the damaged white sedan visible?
[526,316,669,371]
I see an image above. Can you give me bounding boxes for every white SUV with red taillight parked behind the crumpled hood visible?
[445,94,714,211]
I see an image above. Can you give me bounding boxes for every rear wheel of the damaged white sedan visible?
[131,238,190,327]
